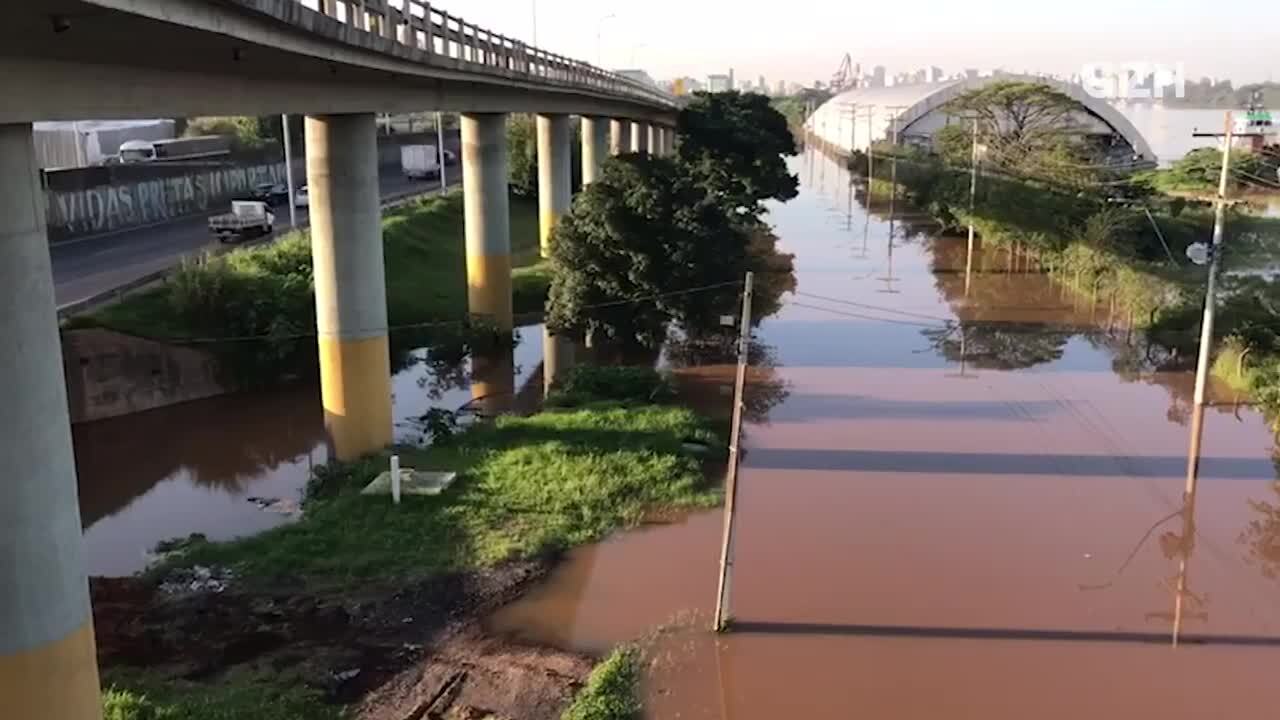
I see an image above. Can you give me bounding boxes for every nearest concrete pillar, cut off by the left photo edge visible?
[0,123,102,720]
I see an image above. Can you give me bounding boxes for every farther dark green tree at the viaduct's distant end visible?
[677,91,799,217]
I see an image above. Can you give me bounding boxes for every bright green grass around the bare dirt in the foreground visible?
[104,368,723,720]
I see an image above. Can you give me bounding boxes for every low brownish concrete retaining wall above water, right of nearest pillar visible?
[63,328,230,423]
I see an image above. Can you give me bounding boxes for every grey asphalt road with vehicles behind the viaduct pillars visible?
[50,165,445,307]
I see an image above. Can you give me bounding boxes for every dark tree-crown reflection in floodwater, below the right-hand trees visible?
[920,323,1076,370]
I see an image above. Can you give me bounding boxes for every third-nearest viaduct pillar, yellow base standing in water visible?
[462,113,512,331]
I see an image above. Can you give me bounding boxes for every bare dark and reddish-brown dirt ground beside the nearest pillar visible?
[91,561,593,720]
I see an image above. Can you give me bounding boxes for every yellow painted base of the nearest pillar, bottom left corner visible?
[0,620,102,720]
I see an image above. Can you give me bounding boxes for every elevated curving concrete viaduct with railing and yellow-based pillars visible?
[0,0,678,720]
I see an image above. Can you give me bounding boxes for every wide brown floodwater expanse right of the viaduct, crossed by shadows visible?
[490,148,1280,720]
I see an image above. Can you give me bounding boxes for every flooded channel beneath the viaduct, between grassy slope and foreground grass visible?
[73,325,543,575]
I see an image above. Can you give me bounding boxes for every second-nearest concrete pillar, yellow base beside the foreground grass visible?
[306,113,392,460]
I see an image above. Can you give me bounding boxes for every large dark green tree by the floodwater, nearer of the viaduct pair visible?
[547,155,750,348]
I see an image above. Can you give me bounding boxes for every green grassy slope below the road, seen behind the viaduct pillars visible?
[68,192,550,384]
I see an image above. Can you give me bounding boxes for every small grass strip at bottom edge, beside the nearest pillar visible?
[102,669,342,720]
